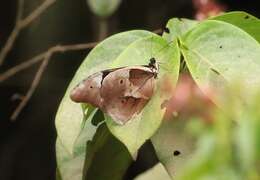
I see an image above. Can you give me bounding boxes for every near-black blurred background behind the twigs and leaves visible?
[0,0,260,180]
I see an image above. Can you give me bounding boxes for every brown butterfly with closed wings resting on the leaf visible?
[70,58,159,124]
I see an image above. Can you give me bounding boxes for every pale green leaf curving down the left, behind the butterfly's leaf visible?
[55,30,152,154]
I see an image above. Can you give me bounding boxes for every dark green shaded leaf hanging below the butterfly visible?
[83,123,132,180]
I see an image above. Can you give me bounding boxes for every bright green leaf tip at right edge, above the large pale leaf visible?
[212,11,260,42]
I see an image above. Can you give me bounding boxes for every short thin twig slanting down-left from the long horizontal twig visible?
[10,53,51,121]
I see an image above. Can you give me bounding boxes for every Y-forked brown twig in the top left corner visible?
[0,0,56,66]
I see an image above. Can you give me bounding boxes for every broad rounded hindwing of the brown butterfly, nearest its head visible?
[101,66,155,124]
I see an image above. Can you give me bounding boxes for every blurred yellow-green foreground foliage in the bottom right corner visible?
[177,88,260,180]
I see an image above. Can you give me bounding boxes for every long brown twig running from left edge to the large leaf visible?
[0,42,98,83]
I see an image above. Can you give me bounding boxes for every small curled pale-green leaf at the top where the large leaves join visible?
[163,18,198,42]
